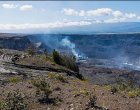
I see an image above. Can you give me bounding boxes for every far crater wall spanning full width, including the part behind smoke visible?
[0,34,140,59]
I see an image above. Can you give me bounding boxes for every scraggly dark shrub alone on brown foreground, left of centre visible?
[32,78,52,101]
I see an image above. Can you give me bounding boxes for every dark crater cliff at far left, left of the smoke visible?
[0,36,31,50]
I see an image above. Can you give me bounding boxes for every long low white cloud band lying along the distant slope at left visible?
[0,21,91,30]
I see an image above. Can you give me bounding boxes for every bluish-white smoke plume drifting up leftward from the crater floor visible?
[30,34,84,59]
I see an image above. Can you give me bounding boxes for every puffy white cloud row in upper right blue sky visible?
[63,8,140,22]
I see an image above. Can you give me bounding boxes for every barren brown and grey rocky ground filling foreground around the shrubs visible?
[0,49,140,110]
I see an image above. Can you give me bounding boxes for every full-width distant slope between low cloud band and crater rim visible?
[0,21,140,34]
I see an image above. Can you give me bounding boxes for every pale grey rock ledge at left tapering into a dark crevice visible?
[0,49,83,79]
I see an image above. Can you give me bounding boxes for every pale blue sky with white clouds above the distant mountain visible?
[0,1,140,31]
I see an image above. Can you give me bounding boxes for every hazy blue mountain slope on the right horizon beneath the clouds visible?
[50,22,140,34]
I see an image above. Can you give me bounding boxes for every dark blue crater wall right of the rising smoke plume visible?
[66,34,140,58]
